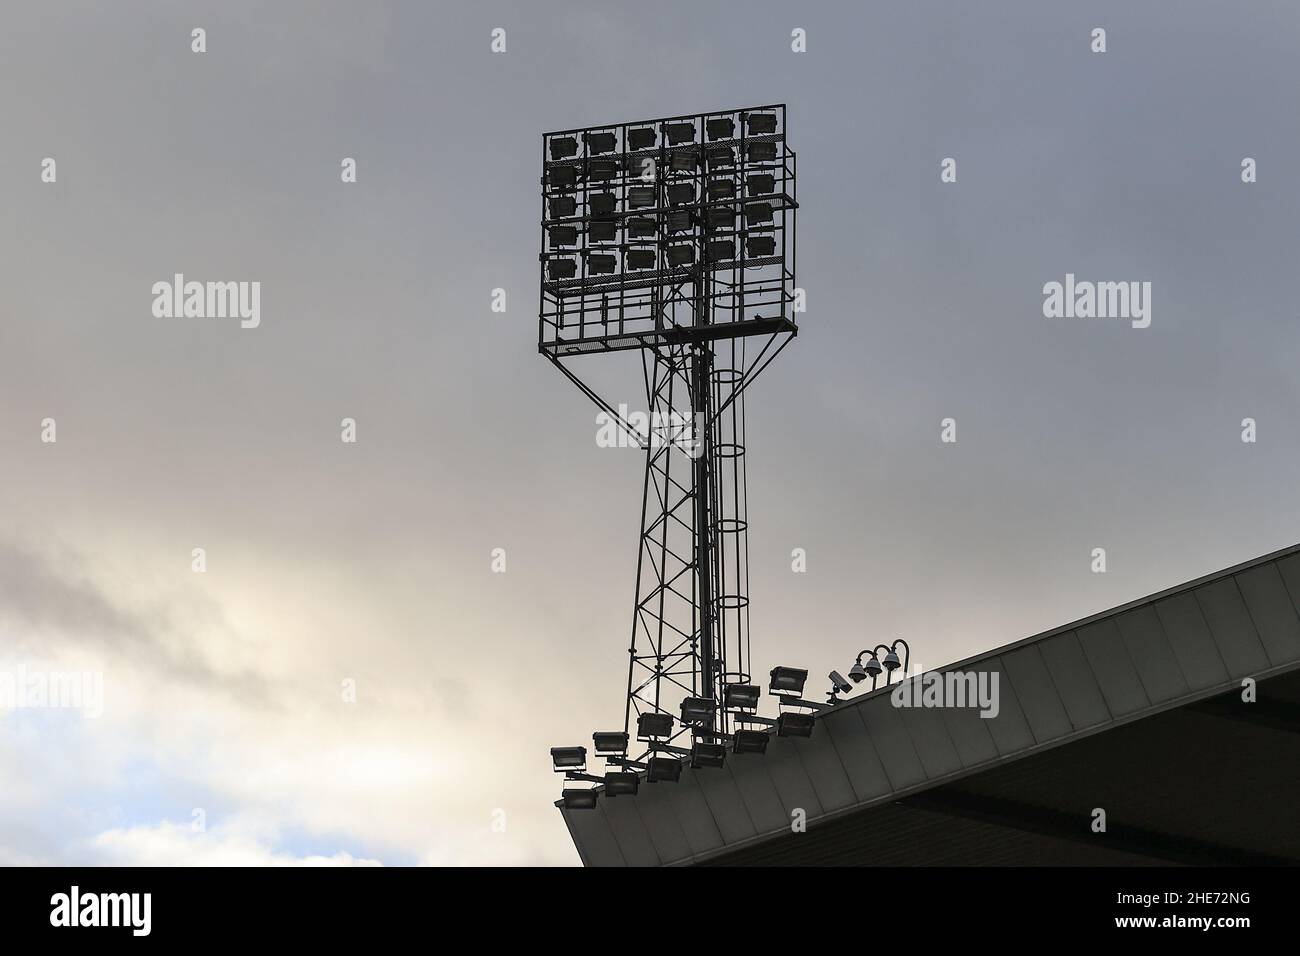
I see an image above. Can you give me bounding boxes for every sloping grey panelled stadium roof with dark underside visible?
[562,545,1300,866]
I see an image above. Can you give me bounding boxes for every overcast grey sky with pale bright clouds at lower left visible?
[0,0,1300,864]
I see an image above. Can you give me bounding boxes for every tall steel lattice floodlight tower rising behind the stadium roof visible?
[538,105,798,779]
